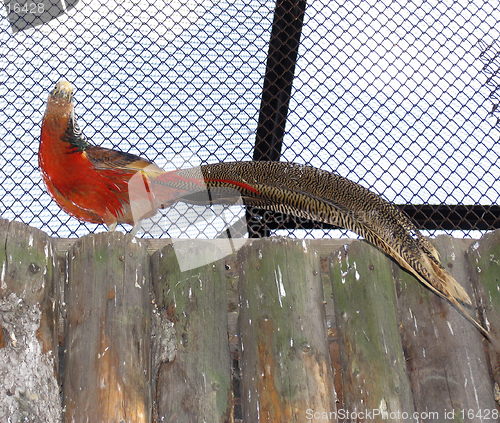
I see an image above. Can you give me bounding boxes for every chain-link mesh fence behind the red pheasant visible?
[0,0,500,237]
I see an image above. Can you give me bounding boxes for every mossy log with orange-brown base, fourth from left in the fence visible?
[238,238,335,423]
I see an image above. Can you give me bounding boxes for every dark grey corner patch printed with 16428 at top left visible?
[4,0,79,33]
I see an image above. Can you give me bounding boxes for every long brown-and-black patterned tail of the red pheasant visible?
[153,162,489,337]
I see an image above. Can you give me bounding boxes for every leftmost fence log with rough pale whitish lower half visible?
[0,219,61,422]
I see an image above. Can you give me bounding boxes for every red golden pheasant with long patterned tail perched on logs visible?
[39,81,488,336]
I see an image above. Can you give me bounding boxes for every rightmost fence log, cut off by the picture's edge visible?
[466,230,500,409]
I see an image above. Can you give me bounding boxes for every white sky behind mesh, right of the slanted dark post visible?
[285,0,500,204]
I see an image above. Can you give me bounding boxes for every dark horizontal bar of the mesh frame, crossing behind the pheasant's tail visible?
[245,204,500,232]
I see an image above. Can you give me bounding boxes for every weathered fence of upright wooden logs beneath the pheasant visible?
[0,220,500,423]
